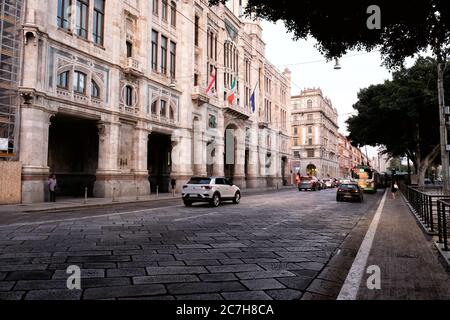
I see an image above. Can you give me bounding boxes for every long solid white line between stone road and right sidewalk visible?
[337,191,387,300]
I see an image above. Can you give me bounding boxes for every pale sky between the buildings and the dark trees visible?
[262,21,398,156]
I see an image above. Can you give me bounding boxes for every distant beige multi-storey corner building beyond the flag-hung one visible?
[291,88,339,178]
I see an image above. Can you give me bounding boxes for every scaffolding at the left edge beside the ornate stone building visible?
[0,0,25,161]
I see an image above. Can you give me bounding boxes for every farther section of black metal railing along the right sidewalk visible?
[400,184,450,232]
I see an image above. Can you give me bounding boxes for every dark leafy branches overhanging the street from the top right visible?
[209,0,450,192]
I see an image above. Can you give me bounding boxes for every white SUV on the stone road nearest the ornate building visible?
[181,177,241,207]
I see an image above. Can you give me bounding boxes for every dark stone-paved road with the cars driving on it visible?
[0,190,381,300]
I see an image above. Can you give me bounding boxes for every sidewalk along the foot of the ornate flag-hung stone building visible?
[0,186,294,215]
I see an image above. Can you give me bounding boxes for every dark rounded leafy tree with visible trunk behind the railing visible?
[347,58,444,185]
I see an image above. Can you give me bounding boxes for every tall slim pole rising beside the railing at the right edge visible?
[438,59,450,194]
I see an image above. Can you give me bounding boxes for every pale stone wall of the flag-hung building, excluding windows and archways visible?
[20,0,290,202]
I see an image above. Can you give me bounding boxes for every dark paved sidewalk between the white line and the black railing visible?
[358,194,450,300]
